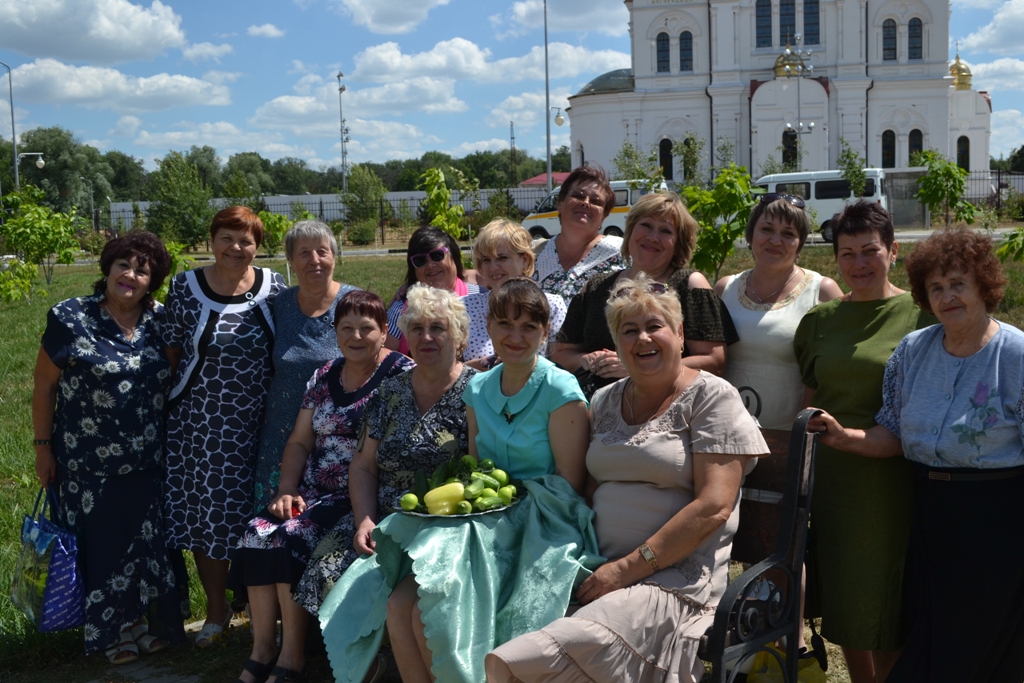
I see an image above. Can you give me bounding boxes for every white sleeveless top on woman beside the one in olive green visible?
[722,268,821,429]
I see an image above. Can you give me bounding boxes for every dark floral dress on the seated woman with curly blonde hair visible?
[294,367,476,614]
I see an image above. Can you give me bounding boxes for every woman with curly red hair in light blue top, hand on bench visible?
[812,230,1024,683]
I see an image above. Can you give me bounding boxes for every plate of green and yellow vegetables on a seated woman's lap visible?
[396,455,526,517]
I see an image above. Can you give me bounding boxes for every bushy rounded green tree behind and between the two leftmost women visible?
[146,152,213,248]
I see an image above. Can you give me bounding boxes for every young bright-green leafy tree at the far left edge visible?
[0,185,78,286]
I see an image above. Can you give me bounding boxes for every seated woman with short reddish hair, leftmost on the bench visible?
[228,291,413,683]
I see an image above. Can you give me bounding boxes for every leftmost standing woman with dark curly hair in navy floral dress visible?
[32,231,187,664]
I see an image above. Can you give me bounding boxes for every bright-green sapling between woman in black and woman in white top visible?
[682,164,755,282]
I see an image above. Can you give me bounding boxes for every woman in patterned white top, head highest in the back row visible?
[534,166,625,302]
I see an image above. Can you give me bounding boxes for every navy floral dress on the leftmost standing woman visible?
[42,292,187,654]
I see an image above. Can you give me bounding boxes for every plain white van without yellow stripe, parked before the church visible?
[754,168,889,242]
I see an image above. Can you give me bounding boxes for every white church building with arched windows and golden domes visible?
[567,0,992,181]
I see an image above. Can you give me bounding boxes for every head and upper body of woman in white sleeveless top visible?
[715,193,843,430]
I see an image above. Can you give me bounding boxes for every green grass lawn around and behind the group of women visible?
[6,245,1024,683]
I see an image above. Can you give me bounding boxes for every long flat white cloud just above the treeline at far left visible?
[14,59,231,113]
